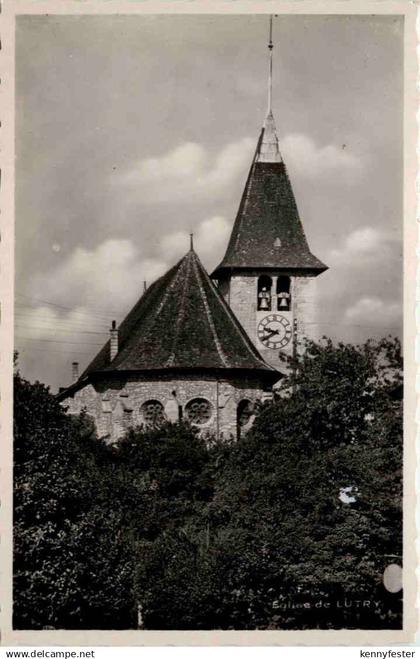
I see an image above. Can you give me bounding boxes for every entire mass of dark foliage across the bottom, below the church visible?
[15,339,402,629]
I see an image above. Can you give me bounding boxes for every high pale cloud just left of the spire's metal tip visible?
[112,137,255,204]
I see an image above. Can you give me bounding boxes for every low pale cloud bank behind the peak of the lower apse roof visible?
[26,216,230,324]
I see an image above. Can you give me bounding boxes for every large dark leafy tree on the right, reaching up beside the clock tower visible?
[137,339,402,629]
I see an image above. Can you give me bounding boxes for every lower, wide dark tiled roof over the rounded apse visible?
[75,250,279,380]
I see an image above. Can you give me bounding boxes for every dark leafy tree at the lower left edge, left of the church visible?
[14,373,136,629]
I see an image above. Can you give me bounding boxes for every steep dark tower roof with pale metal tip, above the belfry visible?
[212,110,327,279]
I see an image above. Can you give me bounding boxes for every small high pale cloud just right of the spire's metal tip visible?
[280,133,363,179]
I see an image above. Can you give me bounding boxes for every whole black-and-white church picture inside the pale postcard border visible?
[3,3,415,638]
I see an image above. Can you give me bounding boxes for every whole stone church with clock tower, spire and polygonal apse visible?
[58,25,327,443]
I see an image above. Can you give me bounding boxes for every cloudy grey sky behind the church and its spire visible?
[15,14,403,392]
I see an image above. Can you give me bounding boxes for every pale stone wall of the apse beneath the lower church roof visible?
[62,376,269,442]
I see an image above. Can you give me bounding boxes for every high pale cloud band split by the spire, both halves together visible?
[111,133,363,204]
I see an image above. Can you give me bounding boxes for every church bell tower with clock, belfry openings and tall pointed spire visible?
[212,17,327,370]
